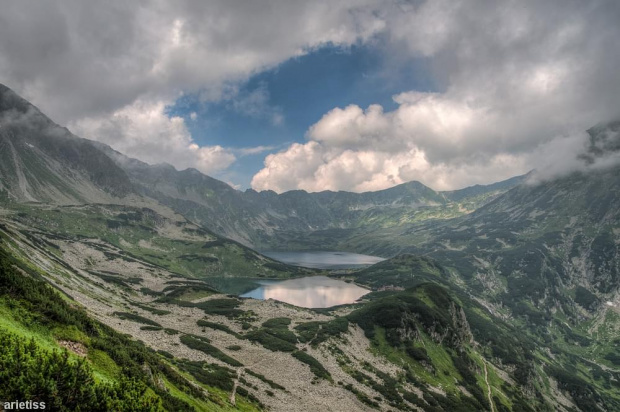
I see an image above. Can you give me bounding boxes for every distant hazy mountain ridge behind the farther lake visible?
[95,143,524,249]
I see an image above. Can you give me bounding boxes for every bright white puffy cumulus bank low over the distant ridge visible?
[252,93,600,192]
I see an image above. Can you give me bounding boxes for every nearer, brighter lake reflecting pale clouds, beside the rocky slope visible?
[241,276,370,308]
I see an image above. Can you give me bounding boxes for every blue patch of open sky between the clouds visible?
[168,45,435,188]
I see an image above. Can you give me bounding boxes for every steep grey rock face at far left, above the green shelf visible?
[0,85,131,204]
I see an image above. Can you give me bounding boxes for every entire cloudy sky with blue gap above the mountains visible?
[0,0,620,192]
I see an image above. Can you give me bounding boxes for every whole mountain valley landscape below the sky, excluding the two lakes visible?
[0,81,620,412]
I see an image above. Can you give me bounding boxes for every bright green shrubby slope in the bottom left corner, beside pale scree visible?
[0,241,260,411]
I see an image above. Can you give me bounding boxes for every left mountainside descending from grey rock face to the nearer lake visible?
[0,85,310,282]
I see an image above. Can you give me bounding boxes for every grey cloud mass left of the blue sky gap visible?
[0,0,385,171]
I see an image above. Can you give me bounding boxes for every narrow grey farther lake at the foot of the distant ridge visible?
[261,251,385,269]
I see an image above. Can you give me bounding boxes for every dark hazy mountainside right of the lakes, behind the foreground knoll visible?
[345,167,620,327]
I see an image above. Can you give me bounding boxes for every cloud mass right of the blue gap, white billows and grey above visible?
[252,0,620,191]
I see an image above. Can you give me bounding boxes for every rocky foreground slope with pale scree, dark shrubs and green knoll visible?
[0,206,620,411]
